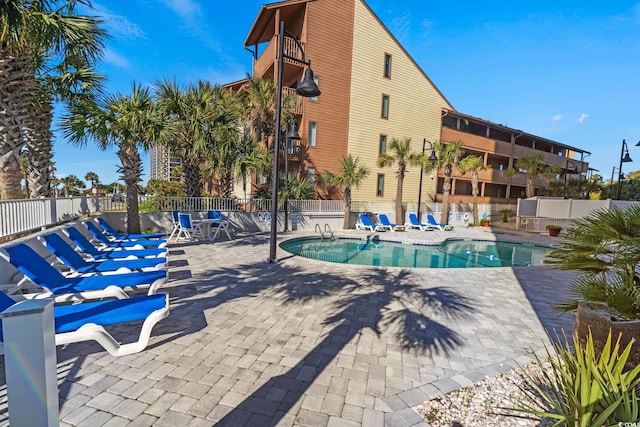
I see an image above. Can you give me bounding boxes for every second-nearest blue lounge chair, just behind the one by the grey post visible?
[0,243,167,302]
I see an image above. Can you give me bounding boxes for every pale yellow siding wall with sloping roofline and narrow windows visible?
[348,0,452,202]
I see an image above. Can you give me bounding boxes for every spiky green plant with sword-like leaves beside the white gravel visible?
[501,333,640,427]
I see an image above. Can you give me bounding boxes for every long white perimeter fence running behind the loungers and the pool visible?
[10,196,638,238]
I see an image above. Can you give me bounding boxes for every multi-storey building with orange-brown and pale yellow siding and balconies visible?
[244,0,589,203]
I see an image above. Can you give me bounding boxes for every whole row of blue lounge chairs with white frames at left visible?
[0,219,169,356]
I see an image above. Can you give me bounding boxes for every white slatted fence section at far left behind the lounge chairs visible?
[0,197,98,238]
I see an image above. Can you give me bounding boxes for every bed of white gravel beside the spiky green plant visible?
[414,362,553,427]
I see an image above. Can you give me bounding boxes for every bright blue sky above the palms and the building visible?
[54,0,640,187]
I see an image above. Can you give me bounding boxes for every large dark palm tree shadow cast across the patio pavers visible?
[217,270,474,426]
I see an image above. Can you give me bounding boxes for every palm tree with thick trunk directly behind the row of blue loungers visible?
[63,82,165,234]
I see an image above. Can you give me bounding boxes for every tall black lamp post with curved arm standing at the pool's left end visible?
[268,21,320,262]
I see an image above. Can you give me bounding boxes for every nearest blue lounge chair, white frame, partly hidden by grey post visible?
[0,292,169,356]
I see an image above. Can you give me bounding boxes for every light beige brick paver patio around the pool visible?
[0,228,573,427]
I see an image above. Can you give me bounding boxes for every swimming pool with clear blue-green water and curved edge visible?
[280,237,549,268]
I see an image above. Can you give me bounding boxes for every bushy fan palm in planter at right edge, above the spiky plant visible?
[545,206,640,320]
